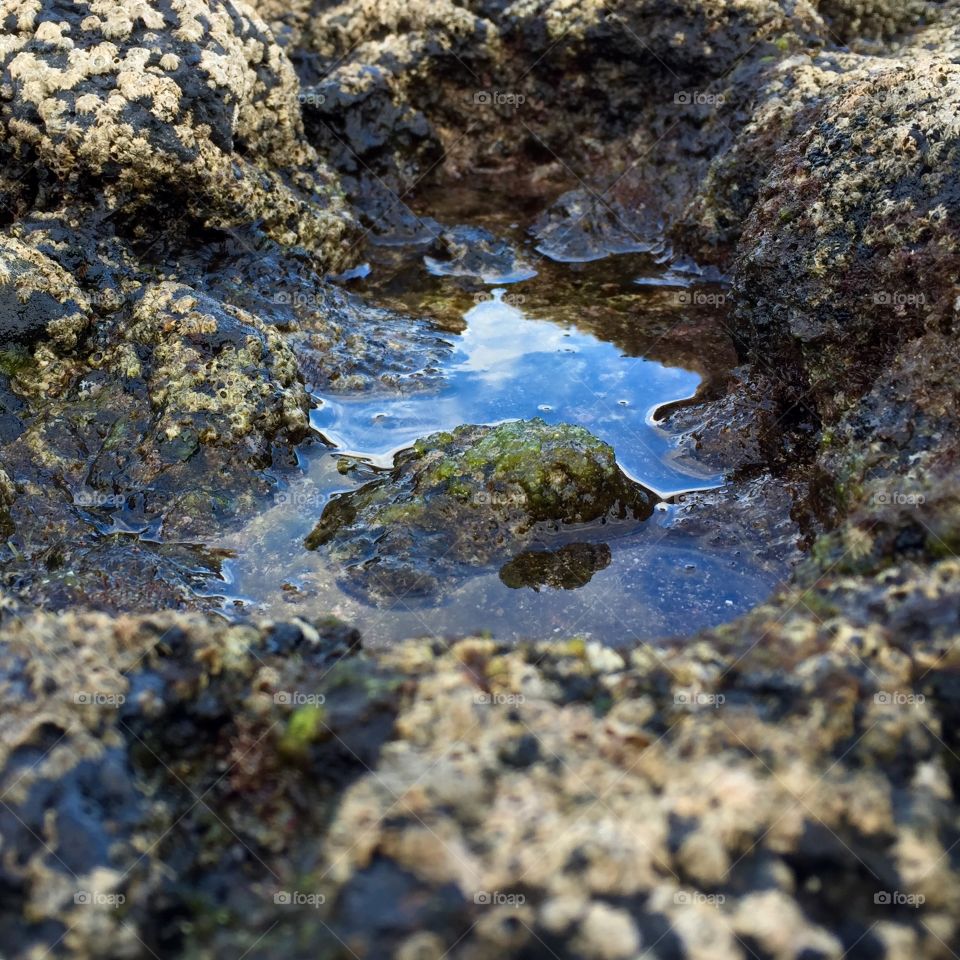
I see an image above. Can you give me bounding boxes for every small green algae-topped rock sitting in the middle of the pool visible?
[306,419,655,600]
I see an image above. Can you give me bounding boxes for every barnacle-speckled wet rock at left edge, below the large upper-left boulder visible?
[0,270,316,610]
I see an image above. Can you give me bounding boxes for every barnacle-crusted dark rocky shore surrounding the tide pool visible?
[0,0,960,960]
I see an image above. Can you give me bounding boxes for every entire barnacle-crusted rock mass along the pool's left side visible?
[0,2,458,610]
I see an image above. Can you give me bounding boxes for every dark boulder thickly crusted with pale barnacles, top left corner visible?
[0,0,350,265]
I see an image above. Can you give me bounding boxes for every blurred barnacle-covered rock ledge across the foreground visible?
[0,588,960,960]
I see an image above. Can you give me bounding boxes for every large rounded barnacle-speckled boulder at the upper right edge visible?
[736,54,960,420]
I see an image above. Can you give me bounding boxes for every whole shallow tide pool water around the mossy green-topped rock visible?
[204,182,782,644]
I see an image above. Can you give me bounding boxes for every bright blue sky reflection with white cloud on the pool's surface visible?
[311,288,708,495]
